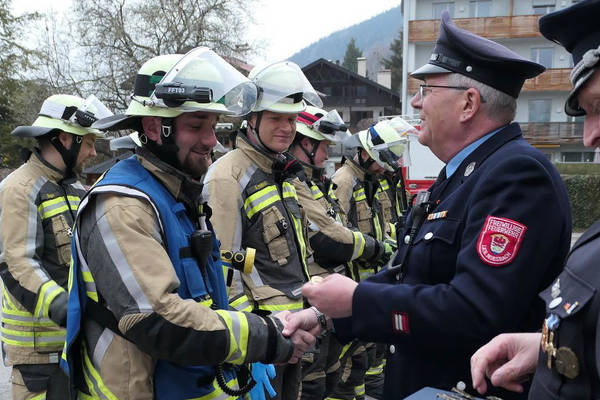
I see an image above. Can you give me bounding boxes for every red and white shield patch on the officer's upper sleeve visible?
[477,215,527,267]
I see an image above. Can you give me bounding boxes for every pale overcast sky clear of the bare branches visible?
[13,0,400,64]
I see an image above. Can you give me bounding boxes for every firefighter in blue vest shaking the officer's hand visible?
[61,47,314,400]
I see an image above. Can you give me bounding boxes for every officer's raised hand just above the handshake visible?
[302,274,358,318]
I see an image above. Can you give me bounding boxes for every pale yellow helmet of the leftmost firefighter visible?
[11,94,112,137]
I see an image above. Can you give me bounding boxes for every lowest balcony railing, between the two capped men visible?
[520,122,583,144]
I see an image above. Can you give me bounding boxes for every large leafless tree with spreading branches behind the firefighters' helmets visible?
[34,0,254,110]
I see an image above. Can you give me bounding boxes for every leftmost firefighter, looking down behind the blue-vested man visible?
[0,95,110,399]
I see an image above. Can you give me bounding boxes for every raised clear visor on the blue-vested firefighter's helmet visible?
[150,47,257,116]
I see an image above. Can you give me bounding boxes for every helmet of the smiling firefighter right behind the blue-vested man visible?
[248,61,323,114]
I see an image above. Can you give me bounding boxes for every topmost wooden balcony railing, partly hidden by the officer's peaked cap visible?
[408,15,541,42]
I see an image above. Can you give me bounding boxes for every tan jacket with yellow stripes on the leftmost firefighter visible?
[0,150,85,365]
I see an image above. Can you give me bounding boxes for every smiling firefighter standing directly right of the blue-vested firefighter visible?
[204,61,321,400]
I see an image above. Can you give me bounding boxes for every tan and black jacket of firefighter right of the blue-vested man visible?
[203,132,309,311]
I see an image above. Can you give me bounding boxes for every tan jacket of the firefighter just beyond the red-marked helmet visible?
[332,160,386,280]
